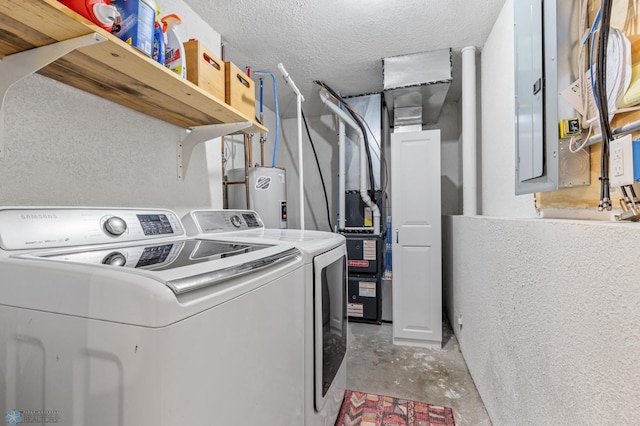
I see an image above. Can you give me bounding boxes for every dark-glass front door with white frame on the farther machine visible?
[313,246,347,411]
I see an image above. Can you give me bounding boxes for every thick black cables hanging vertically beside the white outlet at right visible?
[595,0,613,210]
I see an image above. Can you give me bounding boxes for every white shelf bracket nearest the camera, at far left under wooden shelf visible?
[0,33,107,158]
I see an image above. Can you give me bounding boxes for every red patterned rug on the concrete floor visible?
[336,390,456,426]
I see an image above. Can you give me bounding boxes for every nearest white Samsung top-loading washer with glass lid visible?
[0,208,307,426]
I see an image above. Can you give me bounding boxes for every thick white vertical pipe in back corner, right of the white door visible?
[462,46,478,216]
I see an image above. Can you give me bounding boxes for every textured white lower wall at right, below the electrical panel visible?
[443,216,640,425]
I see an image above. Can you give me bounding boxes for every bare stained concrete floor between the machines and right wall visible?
[347,320,491,426]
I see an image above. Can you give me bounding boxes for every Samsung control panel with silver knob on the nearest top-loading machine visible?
[0,208,184,250]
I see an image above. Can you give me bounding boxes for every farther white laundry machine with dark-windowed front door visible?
[182,210,347,426]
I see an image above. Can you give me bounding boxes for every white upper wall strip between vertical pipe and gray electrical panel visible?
[479,0,536,217]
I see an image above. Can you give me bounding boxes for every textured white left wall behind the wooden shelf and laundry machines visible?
[0,1,222,213]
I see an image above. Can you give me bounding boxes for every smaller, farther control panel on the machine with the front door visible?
[183,210,264,235]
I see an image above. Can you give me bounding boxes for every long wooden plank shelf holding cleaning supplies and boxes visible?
[0,0,267,133]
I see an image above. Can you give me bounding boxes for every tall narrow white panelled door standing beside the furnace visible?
[391,130,442,348]
